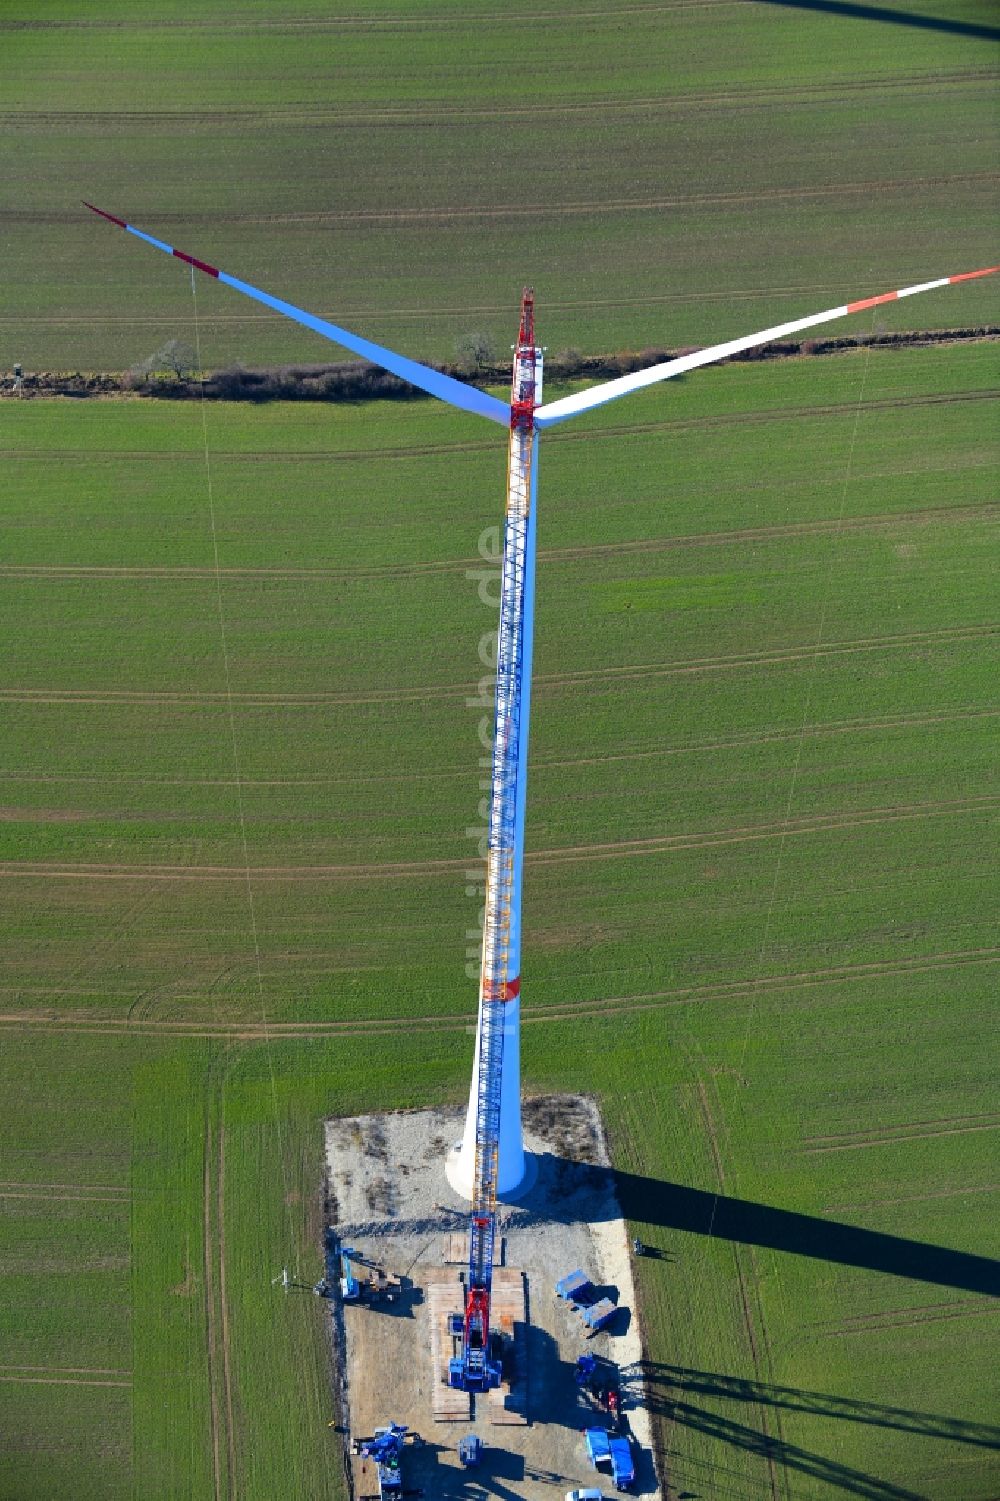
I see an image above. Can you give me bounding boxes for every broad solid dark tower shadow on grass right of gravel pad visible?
[614,1172,1000,1297]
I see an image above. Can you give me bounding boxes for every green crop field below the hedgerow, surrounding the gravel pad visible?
[0,334,1000,1501]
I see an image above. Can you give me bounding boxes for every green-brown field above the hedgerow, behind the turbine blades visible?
[0,0,1000,369]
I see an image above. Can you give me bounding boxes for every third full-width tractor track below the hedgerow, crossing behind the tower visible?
[0,624,1000,708]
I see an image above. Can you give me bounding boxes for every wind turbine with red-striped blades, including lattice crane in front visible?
[86,203,1000,1391]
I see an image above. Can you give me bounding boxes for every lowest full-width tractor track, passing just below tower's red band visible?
[0,947,1000,1040]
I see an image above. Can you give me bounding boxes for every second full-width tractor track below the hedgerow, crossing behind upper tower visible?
[0,503,997,582]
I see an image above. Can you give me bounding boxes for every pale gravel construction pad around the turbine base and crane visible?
[326,1096,661,1501]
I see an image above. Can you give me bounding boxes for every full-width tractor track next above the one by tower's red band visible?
[0,794,1000,883]
